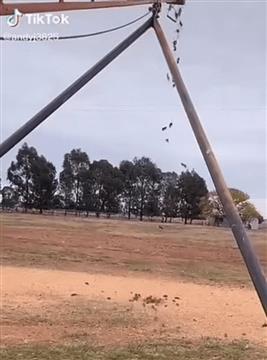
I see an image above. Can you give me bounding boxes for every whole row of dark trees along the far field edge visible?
[1,143,260,223]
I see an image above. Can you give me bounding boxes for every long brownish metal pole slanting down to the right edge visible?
[154,17,267,315]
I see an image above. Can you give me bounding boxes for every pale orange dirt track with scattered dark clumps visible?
[2,267,267,346]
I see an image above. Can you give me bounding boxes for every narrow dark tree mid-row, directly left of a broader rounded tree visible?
[120,160,137,220]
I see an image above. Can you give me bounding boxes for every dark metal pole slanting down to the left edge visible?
[0,17,153,158]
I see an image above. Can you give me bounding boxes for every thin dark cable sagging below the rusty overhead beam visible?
[0,11,151,42]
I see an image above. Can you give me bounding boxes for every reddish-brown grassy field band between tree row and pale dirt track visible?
[2,215,267,285]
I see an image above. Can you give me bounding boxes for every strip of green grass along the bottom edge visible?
[0,340,267,360]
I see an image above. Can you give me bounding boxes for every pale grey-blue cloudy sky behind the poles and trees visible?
[1,0,267,216]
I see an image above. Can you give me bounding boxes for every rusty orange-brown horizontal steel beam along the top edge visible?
[0,0,185,16]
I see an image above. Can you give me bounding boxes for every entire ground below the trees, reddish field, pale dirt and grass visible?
[0,214,267,360]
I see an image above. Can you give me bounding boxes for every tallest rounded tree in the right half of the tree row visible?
[133,157,161,221]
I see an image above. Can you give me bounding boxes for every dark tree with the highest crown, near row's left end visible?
[7,143,38,211]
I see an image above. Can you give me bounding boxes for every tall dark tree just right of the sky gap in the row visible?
[59,149,90,211]
